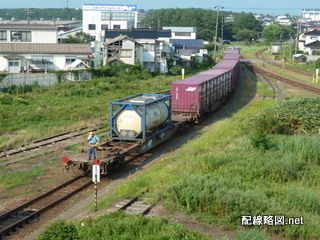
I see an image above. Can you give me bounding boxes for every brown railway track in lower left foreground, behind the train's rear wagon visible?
[0,176,92,239]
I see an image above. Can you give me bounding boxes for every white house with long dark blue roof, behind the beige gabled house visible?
[105,28,171,73]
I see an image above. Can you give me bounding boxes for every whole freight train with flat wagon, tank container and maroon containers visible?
[62,48,240,174]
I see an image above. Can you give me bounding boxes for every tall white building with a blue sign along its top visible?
[82,4,138,41]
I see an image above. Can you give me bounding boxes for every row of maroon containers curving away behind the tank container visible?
[171,49,240,119]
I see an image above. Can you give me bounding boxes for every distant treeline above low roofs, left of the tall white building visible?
[0,8,82,20]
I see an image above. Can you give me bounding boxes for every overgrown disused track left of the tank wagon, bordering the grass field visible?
[0,127,104,161]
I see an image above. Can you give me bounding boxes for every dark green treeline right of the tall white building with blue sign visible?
[143,8,296,42]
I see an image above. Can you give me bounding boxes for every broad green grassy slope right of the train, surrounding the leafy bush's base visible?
[96,94,320,239]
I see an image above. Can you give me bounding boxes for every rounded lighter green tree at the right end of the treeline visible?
[262,24,291,42]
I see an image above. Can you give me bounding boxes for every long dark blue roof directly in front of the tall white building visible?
[105,28,171,39]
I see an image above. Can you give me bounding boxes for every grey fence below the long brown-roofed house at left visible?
[0,71,91,88]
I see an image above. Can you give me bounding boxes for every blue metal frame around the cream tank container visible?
[110,93,172,141]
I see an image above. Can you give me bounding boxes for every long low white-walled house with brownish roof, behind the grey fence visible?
[0,43,92,73]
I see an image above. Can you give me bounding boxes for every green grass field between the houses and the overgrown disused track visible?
[0,62,215,148]
